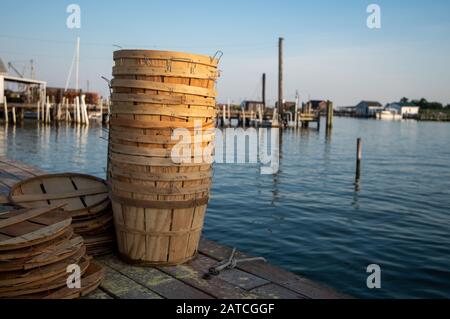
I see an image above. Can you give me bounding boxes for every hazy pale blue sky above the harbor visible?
[0,0,450,106]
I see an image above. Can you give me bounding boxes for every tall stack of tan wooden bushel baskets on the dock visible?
[108,50,219,266]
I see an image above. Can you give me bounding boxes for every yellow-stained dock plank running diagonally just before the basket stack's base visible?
[99,255,212,299]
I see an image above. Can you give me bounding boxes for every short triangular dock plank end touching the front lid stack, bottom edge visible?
[100,262,161,299]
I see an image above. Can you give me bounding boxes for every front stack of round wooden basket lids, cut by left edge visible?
[0,206,104,299]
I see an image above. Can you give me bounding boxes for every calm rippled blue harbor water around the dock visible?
[0,118,450,298]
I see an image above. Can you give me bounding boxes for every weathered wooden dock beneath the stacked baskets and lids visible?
[0,157,350,299]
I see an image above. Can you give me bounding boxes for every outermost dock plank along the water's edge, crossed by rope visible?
[199,239,351,299]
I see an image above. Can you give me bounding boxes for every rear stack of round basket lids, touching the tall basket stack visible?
[9,173,115,256]
